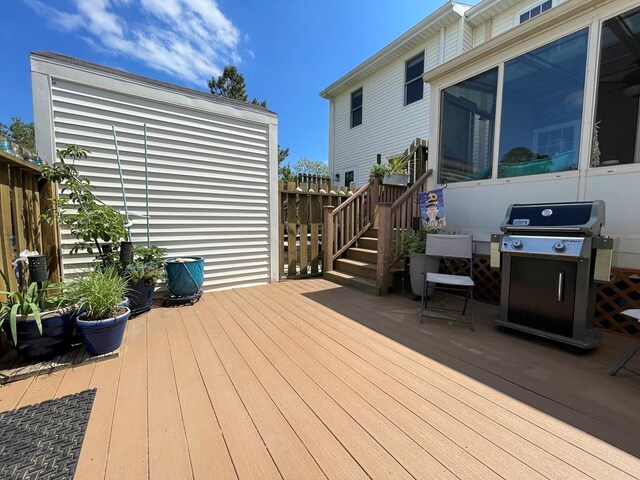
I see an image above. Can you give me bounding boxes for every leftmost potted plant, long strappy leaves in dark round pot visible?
[0,271,72,357]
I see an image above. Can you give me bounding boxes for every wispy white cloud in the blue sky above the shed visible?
[23,0,241,87]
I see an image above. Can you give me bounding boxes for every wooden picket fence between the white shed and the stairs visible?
[278,181,353,279]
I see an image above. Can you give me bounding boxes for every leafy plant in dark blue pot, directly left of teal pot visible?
[124,246,167,315]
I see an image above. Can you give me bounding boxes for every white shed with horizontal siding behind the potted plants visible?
[31,52,278,290]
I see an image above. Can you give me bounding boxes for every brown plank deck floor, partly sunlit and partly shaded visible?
[0,280,640,480]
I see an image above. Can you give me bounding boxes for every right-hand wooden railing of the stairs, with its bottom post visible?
[377,170,432,287]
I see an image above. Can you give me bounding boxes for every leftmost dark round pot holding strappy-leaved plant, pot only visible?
[2,312,73,358]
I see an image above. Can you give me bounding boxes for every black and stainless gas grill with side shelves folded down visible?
[491,200,613,349]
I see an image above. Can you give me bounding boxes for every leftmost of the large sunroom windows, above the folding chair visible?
[439,68,498,183]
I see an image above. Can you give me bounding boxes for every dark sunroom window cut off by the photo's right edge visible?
[591,4,640,167]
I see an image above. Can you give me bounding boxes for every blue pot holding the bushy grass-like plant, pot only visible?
[76,307,131,355]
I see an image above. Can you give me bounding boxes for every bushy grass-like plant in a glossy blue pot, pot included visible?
[67,268,131,355]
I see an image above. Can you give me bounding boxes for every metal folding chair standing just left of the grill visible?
[420,234,475,331]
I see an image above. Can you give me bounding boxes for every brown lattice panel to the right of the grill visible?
[594,268,640,337]
